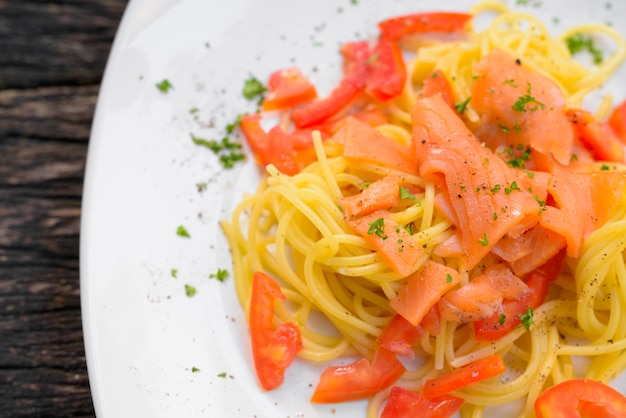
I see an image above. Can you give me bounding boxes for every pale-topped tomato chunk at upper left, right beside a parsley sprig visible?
[263,67,317,111]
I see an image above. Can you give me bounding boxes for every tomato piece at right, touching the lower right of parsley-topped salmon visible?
[566,109,624,162]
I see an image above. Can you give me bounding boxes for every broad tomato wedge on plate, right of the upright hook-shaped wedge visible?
[311,347,406,403]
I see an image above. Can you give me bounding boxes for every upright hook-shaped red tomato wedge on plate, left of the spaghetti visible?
[249,271,302,390]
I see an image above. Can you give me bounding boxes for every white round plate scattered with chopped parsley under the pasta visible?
[81,0,626,418]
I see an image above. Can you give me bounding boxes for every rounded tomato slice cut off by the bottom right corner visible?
[535,379,626,418]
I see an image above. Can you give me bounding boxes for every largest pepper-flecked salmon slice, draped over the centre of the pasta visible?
[411,96,540,270]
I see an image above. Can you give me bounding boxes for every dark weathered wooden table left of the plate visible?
[0,0,127,417]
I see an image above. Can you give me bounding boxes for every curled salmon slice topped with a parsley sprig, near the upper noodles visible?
[471,50,574,165]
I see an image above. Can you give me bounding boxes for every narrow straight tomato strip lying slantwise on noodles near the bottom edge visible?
[423,354,506,399]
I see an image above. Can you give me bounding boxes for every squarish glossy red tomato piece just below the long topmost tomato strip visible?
[365,38,406,101]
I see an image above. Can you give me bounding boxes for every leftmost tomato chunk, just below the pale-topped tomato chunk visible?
[240,113,300,175]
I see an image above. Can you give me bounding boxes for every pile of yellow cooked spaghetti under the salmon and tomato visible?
[222,2,626,417]
